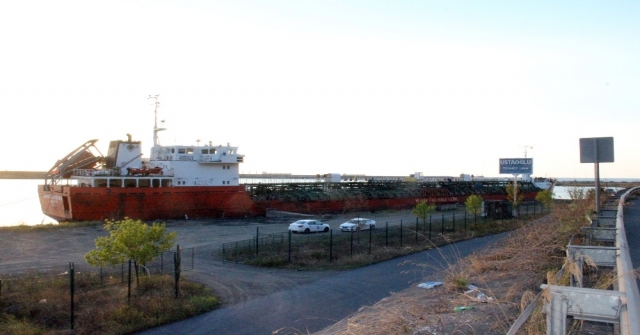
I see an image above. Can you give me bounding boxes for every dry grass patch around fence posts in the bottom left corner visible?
[0,274,219,335]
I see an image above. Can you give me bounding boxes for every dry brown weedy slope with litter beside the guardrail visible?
[321,200,612,335]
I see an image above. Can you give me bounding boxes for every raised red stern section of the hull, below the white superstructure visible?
[38,185,257,221]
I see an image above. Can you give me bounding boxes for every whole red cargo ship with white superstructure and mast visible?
[38,97,552,221]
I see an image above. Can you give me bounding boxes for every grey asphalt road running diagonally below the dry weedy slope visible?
[140,233,506,335]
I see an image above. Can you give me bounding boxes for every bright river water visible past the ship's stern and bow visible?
[0,179,624,226]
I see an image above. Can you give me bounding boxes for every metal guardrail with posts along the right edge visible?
[507,187,640,335]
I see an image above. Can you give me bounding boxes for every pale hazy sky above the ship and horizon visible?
[0,0,640,178]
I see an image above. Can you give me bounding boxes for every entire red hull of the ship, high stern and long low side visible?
[38,185,536,221]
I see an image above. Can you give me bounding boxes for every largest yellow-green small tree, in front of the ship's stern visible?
[84,218,177,285]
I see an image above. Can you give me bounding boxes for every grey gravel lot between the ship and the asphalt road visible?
[0,211,424,305]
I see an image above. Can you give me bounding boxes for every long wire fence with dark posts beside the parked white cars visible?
[219,203,548,265]
